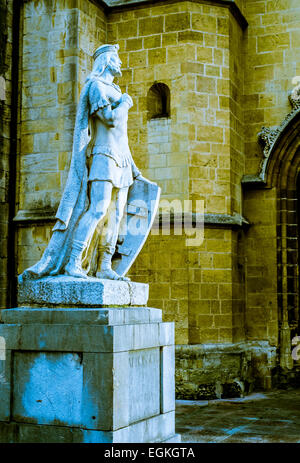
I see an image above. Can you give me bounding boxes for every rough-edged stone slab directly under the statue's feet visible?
[18,275,149,307]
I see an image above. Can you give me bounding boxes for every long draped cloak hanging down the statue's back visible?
[19,79,93,281]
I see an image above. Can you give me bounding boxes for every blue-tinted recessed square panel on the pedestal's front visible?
[12,352,83,426]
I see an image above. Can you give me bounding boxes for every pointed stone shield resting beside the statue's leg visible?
[106,177,161,276]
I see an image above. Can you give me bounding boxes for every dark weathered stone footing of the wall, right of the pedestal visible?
[176,341,276,400]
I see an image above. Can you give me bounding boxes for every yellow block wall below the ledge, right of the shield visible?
[130,226,244,344]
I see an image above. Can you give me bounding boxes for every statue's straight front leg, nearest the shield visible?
[98,188,130,281]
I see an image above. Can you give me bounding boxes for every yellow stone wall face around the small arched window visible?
[107,2,192,203]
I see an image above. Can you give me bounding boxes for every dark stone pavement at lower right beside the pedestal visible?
[176,389,300,443]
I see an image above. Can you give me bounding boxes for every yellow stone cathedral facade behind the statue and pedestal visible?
[0,0,300,399]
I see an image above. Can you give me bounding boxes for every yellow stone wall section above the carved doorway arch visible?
[244,0,300,174]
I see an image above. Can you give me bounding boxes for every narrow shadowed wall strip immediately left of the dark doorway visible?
[244,189,278,345]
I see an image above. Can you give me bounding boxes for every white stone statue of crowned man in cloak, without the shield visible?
[19,45,158,280]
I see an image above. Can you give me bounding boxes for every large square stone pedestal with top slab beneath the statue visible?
[0,277,180,443]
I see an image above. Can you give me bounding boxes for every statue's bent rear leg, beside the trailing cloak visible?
[65,180,113,278]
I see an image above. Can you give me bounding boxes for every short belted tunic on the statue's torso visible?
[88,78,140,188]
